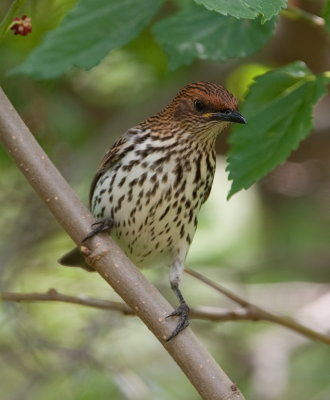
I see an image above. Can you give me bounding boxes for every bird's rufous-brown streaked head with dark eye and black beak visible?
[164,82,246,137]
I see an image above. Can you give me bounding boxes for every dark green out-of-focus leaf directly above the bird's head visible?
[153,6,275,69]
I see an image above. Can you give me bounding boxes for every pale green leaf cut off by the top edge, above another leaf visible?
[194,0,287,21]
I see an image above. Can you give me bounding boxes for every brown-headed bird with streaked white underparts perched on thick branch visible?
[59,82,246,341]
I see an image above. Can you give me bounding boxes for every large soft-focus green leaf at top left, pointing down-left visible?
[12,0,164,79]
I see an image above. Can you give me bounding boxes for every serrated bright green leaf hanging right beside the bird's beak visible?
[227,62,330,197]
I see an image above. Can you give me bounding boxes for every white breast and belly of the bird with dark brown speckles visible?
[92,134,215,267]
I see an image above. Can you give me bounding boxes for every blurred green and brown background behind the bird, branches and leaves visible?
[0,0,330,400]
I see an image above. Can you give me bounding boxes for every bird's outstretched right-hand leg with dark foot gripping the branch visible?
[166,255,190,342]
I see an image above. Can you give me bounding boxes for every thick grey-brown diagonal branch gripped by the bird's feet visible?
[0,89,244,400]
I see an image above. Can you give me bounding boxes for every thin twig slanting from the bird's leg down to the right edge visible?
[185,269,330,345]
